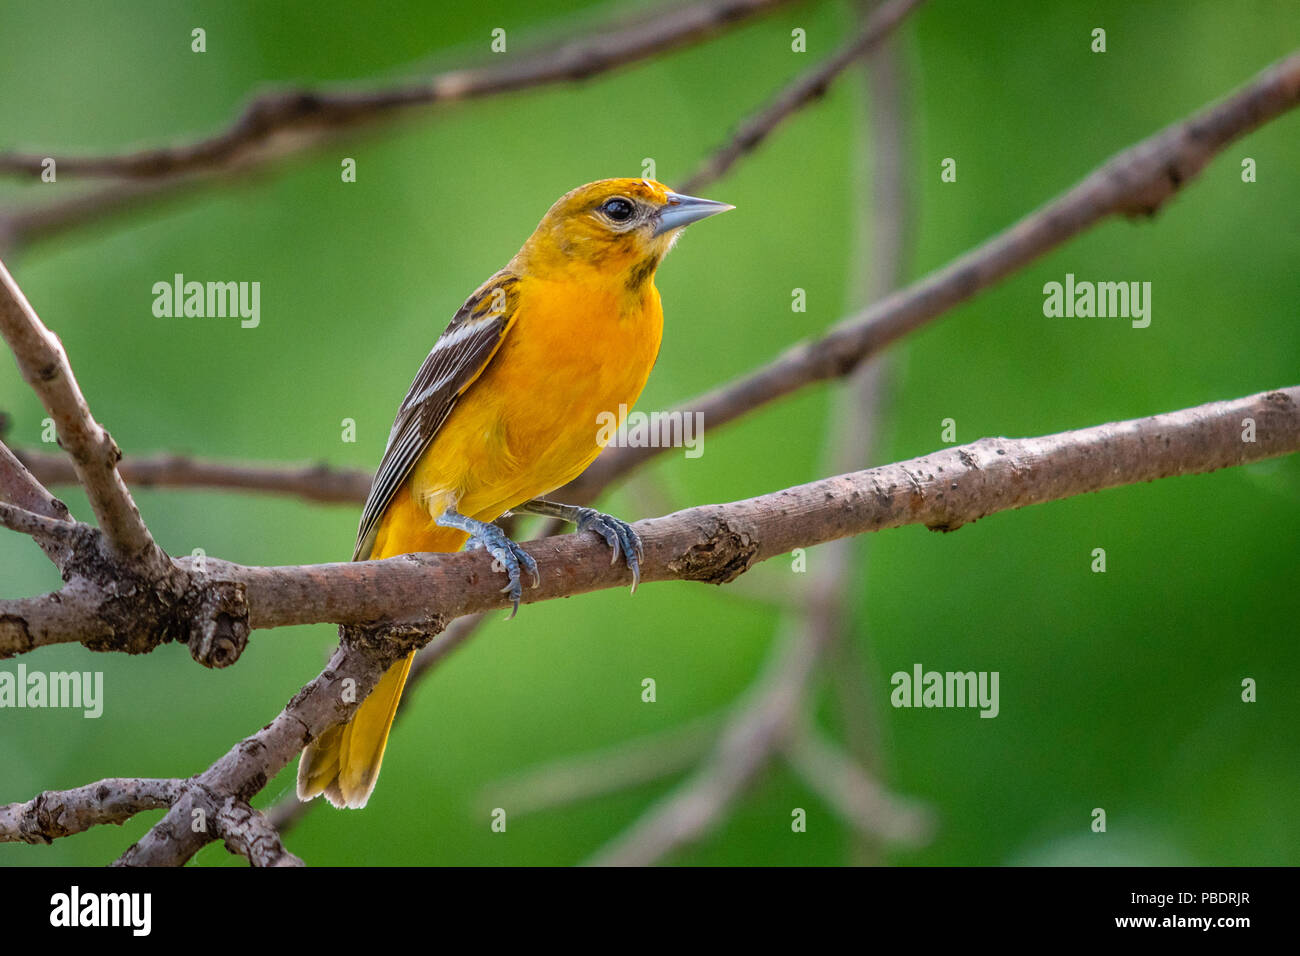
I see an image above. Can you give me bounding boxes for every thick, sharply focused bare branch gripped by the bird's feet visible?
[0,386,1300,657]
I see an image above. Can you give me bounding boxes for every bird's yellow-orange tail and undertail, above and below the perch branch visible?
[298,496,467,809]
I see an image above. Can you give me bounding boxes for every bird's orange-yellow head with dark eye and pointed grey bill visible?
[516,179,735,286]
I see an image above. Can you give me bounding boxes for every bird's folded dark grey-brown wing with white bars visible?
[352,272,519,561]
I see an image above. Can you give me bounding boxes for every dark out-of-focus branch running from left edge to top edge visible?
[0,0,789,178]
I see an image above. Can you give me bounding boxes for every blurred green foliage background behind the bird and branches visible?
[0,0,1300,865]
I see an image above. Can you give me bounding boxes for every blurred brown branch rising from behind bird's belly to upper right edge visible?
[555,53,1300,503]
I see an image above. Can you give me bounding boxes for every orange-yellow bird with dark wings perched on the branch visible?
[298,178,735,809]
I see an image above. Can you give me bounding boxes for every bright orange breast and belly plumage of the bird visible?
[371,271,663,558]
